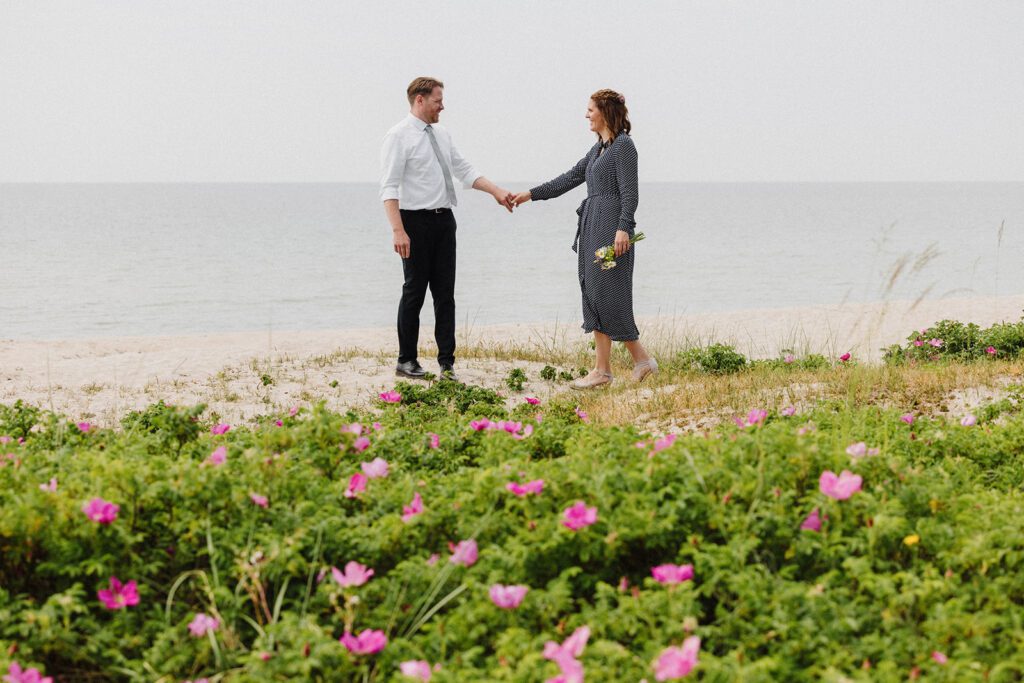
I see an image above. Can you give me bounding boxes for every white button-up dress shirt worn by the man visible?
[381,114,480,211]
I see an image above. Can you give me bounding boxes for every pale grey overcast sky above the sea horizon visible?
[0,0,1024,181]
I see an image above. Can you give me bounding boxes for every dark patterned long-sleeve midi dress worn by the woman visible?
[529,133,640,341]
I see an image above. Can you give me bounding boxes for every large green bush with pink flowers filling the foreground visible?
[0,382,1024,683]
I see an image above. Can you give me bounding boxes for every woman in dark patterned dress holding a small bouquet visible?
[513,90,657,389]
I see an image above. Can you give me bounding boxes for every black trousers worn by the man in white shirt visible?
[398,209,456,365]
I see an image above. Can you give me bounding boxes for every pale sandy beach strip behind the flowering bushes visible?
[0,296,1024,425]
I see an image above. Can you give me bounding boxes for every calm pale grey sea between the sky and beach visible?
[0,183,1024,339]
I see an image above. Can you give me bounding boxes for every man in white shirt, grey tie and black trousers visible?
[380,77,513,380]
